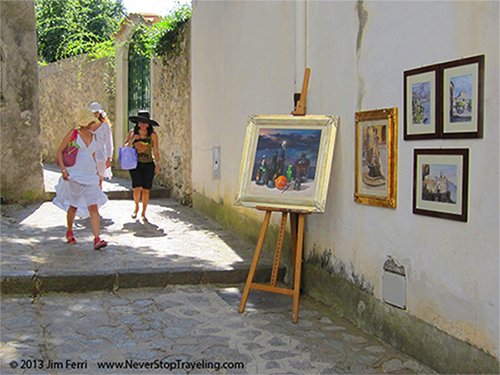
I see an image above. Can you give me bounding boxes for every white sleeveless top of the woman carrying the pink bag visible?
[66,134,99,185]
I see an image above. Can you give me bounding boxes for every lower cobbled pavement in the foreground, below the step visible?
[0,285,434,375]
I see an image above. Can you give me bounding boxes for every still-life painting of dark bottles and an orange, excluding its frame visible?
[250,128,321,196]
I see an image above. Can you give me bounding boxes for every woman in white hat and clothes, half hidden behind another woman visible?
[89,102,114,189]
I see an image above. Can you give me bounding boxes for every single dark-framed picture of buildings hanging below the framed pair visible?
[413,149,469,222]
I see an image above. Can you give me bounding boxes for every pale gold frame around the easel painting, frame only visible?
[235,115,338,212]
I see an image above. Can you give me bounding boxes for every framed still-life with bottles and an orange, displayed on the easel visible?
[235,115,338,212]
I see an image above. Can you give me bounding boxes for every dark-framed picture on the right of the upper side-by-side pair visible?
[441,55,484,138]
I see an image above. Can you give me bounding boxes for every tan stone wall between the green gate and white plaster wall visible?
[151,24,191,204]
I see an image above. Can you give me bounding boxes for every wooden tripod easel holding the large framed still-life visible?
[239,68,311,323]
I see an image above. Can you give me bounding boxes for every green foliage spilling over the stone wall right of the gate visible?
[129,4,191,58]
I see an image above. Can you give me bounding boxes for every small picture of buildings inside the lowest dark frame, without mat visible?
[422,164,457,204]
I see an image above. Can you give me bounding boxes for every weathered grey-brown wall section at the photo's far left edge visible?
[0,0,44,202]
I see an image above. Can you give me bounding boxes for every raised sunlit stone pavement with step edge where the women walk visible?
[0,199,278,293]
